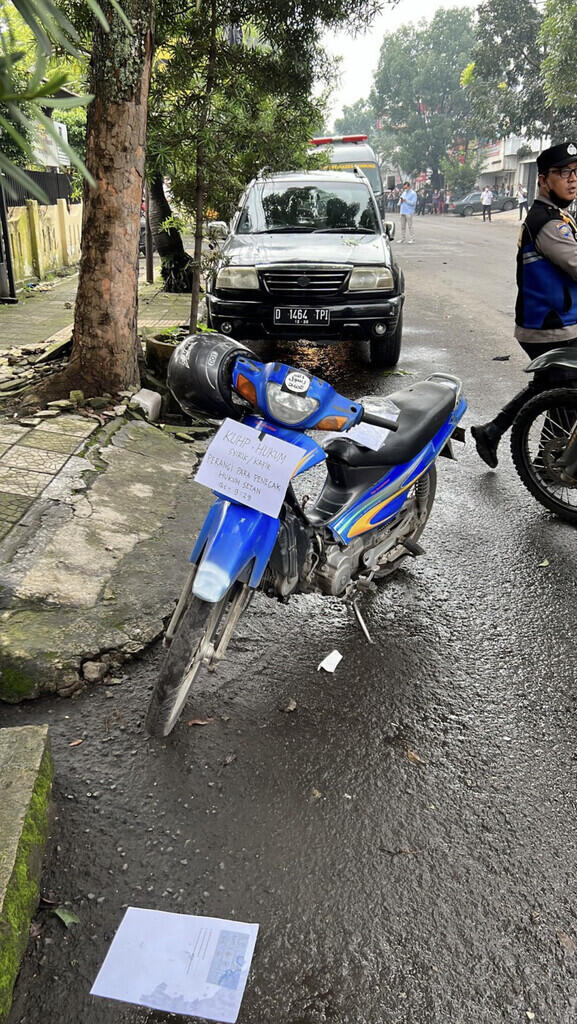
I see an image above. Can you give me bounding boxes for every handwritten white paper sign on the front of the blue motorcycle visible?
[195,419,305,517]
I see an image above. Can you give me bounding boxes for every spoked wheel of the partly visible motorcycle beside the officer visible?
[510,388,577,524]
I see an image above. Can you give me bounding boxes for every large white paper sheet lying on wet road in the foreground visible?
[90,906,258,1024]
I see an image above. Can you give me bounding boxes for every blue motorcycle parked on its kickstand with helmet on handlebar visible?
[146,334,466,736]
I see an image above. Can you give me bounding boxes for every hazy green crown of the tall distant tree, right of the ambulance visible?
[371,9,475,177]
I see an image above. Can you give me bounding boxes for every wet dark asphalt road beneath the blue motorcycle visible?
[4,214,577,1024]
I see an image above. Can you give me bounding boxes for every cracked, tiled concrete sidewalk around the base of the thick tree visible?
[0,268,208,701]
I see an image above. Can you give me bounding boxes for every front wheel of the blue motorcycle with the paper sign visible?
[145,583,253,736]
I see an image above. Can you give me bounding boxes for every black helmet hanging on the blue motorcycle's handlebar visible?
[167,333,253,420]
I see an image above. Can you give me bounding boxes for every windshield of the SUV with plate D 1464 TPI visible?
[237,181,379,234]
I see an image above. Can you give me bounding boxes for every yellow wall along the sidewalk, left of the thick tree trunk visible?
[8,199,82,285]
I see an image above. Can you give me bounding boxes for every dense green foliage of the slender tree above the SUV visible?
[149,2,334,219]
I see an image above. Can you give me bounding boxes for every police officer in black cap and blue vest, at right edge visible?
[470,141,577,469]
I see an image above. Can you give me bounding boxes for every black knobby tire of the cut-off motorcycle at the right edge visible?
[510,388,577,525]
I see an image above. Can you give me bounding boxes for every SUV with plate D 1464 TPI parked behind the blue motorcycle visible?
[206,171,405,367]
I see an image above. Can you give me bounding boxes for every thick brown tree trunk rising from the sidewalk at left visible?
[66,0,154,395]
